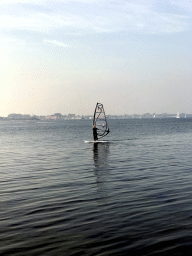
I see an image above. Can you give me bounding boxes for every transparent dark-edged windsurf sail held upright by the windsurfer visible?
[93,103,109,139]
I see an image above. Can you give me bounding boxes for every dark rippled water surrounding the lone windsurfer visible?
[0,119,192,256]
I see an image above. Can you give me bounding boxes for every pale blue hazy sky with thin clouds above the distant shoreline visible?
[0,0,192,116]
